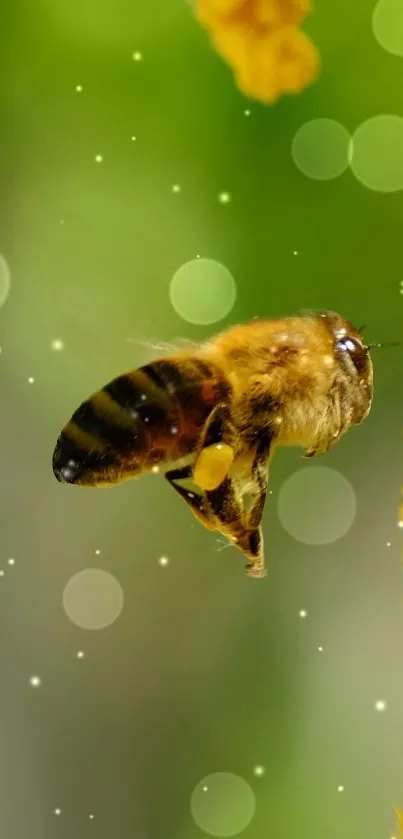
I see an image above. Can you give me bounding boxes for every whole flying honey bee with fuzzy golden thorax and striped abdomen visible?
[53,311,376,577]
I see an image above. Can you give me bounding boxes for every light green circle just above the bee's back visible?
[169,258,236,325]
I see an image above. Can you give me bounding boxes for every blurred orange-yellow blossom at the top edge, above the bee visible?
[196,0,319,103]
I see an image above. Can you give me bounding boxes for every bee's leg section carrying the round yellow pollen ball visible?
[193,404,236,490]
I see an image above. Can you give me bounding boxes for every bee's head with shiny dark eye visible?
[317,312,373,425]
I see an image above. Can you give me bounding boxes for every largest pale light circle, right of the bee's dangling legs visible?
[278,466,357,545]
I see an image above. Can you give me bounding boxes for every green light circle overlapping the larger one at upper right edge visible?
[291,117,351,181]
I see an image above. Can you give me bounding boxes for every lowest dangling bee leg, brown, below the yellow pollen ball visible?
[206,477,266,577]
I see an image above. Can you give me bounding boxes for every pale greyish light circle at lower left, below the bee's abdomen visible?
[63,568,124,629]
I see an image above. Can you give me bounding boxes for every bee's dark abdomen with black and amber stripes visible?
[54,358,229,485]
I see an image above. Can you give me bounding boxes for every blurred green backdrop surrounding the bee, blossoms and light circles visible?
[0,0,403,839]
